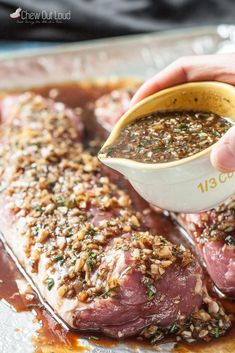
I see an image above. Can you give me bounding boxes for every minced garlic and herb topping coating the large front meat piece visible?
[0,93,230,341]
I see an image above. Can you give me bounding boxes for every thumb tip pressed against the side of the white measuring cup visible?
[211,126,235,172]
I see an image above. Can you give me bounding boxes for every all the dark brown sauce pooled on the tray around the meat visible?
[0,81,235,353]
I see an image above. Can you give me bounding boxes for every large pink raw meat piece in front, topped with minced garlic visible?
[0,93,230,341]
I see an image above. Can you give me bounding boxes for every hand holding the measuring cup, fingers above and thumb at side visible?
[131,53,235,172]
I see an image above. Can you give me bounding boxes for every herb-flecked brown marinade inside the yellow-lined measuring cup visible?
[100,111,231,163]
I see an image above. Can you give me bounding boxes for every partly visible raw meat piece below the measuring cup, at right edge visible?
[178,198,235,297]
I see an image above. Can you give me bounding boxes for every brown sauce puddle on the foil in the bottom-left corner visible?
[0,241,86,353]
